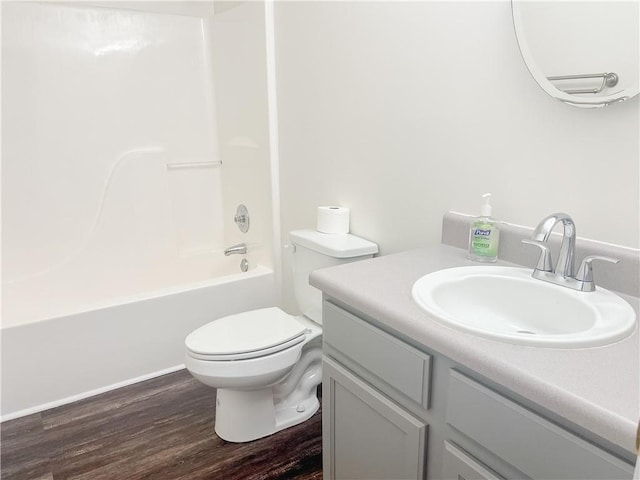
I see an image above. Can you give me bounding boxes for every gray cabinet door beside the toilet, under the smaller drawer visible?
[322,357,427,480]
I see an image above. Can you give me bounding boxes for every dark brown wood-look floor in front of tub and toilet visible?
[0,370,322,480]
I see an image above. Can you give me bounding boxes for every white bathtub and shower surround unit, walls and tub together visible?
[1,2,277,420]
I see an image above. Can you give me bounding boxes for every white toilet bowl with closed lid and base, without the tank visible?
[185,307,322,442]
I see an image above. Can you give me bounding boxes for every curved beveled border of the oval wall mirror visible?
[511,0,640,108]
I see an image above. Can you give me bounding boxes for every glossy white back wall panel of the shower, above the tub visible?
[2,2,225,326]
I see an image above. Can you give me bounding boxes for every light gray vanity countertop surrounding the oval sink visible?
[310,244,640,453]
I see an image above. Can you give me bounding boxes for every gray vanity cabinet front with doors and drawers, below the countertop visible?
[322,301,633,480]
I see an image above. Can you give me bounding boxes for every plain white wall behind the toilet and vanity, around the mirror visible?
[275,1,640,310]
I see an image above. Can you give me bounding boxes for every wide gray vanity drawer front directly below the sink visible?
[446,370,633,480]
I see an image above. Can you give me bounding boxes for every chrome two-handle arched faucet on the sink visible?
[522,213,619,292]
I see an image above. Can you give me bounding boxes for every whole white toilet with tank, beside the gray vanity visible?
[185,230,378,442]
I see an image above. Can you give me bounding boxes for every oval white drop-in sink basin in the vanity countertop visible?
[411,266,636,348]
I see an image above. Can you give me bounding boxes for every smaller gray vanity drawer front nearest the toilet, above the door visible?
[322,301,431,410]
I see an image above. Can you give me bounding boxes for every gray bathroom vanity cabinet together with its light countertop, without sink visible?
[311,215,640,480]
